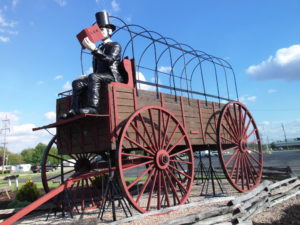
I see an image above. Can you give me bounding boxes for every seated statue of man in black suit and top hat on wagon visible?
[61,11,123,119]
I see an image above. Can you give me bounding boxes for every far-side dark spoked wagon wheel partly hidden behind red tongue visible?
[41,135,105,211]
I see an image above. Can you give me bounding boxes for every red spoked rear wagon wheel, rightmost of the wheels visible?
[217,101,263,192]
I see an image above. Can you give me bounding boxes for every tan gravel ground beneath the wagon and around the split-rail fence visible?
[0,178,300,225]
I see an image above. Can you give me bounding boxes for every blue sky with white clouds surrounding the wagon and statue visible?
[0,0,300,152]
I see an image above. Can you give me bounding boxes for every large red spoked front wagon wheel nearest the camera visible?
[117,106,194,212]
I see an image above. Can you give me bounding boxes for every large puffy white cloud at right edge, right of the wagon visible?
[246,45,300,81]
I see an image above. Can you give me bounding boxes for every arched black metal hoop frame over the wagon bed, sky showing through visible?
[59,16,239,103]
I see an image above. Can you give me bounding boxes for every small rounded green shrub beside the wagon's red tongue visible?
[16,180,40,202]
